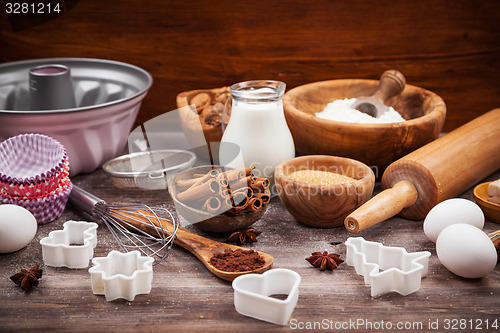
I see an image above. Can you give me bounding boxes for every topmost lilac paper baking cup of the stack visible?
[0,133,67,184]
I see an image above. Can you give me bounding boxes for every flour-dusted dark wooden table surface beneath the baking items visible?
[0,170,500,332]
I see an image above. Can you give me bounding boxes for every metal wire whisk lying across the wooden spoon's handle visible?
[69,186,179,260]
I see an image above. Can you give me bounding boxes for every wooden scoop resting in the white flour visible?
[352,69,406,118]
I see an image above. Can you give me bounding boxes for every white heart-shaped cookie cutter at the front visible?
[233,268,300,325]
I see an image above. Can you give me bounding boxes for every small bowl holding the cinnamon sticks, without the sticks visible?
[168,165,269,233]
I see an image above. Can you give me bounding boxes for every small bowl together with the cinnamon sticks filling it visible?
[168,165,271,233]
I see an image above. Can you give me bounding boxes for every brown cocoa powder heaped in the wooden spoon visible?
[210,249,265,272]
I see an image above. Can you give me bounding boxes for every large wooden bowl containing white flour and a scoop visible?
[284,80,446,172]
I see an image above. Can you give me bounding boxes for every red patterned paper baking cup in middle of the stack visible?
[0,160,69,200]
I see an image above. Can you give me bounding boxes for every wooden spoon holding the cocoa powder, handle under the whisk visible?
[114,210,274,281]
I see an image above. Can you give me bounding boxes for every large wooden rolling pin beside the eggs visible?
[344,109,500,232]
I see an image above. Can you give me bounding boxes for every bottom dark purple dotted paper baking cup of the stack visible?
[2,181,73,224]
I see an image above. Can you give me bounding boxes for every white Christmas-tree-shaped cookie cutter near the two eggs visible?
[345,237,431,297]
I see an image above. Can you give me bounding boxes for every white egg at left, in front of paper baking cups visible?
[0,205,38,253]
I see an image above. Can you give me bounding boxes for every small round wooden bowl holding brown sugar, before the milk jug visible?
[274,155,375,228]
